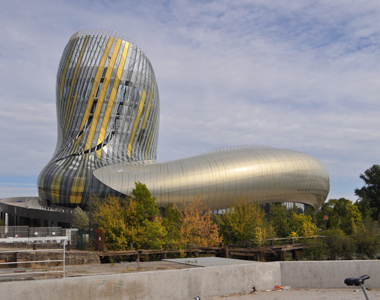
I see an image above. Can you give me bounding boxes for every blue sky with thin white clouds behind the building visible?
[0,0,380,200]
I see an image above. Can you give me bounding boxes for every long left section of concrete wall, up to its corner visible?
[0,262,281,300]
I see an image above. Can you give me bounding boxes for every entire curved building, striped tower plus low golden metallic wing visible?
[38,30,330,210]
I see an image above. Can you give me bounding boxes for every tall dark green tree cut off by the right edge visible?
[355,165,380,220]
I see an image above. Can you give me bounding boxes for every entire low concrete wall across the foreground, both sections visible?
[0,260,380,300]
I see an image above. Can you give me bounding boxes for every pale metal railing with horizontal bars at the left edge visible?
[0,236,68,278]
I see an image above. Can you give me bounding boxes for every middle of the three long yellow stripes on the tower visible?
[84,40,121,150]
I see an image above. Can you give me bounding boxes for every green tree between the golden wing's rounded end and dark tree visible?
[317,198,363,235]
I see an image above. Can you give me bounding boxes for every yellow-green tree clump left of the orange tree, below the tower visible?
[90,182,167,250]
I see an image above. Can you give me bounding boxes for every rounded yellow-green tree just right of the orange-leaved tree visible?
[219,198,268,244]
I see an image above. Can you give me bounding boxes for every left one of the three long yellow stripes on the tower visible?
[72,37,115,153]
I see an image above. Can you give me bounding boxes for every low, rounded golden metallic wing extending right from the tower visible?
[94,148,330,210]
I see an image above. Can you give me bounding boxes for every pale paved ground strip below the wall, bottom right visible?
[202,288,380,300]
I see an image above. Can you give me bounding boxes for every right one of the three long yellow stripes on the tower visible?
[96,42,129,158]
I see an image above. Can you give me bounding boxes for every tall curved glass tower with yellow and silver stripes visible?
[37,29,160,206]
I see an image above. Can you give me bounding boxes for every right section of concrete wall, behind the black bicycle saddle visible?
[281,260,380,288]
